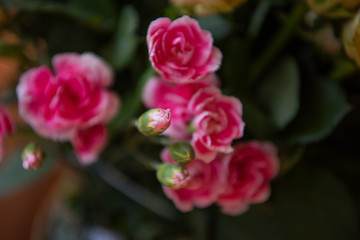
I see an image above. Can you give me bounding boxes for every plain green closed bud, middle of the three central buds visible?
[169,141,195,165]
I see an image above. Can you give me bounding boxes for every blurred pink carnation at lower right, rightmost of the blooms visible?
[217,141,279,215]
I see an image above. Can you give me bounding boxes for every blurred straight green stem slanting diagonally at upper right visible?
[250,1,307,82]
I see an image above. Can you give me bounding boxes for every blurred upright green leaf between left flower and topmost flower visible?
[104,5,139,70]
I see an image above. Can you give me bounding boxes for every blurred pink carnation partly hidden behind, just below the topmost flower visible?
[142,75,218,139]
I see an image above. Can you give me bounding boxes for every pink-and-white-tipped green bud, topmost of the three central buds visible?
[136,108,171,136]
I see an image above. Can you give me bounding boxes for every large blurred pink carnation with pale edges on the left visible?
[17,53,120,163]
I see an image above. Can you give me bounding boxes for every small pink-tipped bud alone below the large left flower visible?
[22,143,45,170]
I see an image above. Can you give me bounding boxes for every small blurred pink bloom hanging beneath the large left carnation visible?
[72,124,107,165]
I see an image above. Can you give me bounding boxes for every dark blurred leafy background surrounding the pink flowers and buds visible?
[0,0,360,240]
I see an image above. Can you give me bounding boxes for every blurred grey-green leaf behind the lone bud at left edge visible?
[0,140,57,195]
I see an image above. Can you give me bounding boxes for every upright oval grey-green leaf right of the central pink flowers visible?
[259,57,300,129]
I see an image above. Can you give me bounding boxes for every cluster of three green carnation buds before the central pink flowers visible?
[136,108,195,190]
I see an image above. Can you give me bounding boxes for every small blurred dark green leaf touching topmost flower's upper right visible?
[196,14,231,41]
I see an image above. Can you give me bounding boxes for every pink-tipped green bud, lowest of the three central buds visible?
[156,163,190,190]
